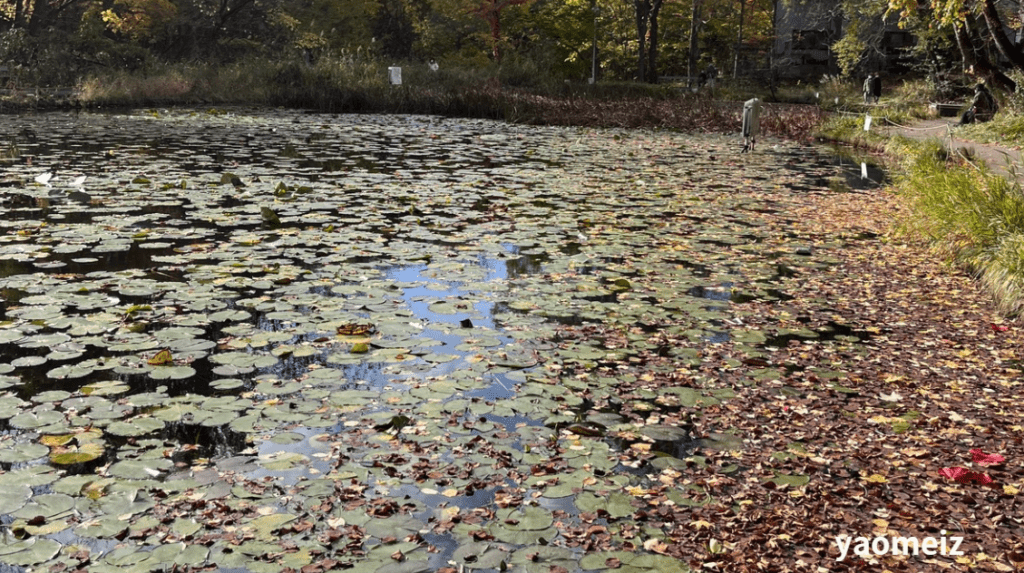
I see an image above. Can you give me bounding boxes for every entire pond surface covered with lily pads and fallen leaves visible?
[0,109,1022,573]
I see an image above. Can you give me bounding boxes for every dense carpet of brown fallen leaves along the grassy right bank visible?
[552,192,1024,571]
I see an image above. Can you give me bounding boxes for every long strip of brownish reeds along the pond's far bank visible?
[72,53,824,139]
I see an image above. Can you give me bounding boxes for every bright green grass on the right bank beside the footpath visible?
[814,75,1024,315]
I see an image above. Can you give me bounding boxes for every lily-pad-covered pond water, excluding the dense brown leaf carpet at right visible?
[0,108,880,573]
